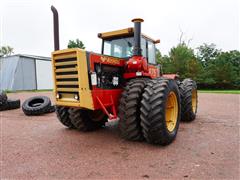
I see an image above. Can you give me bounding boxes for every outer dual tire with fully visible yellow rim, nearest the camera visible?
[140,79,181,145]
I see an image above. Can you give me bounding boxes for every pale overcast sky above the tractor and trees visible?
[0,0,240,56]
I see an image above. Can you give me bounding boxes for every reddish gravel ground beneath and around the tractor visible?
[0,92,240,179]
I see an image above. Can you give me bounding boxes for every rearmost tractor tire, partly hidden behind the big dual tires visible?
[179,79,198,122]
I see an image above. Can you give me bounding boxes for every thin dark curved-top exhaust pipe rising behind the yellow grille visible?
[51,6,59,51]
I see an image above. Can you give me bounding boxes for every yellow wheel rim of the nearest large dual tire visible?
[165,91,178,132]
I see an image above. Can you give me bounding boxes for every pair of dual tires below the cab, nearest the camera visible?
[118,78,181,145]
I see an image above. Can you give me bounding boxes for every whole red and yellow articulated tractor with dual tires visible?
[51,6,197,145]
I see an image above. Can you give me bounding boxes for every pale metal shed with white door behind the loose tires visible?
[0,54,53,91]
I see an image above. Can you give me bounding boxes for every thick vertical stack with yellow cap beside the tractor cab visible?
[132,18,143,56]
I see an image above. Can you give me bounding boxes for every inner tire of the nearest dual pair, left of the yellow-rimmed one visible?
[118,78,148,141]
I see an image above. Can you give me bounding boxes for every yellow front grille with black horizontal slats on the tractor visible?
[52,48,94,110]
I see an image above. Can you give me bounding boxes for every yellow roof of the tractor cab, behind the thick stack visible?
[98,28,160,44]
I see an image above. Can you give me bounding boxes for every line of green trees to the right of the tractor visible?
[157,42,240,89]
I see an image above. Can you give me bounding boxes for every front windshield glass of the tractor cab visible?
[103,37,134,58]
